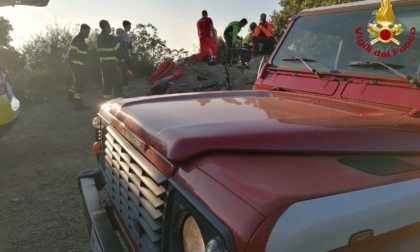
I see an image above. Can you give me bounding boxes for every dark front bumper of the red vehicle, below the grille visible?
[78,169,124,252]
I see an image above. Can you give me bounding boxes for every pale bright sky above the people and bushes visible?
[0,0,280,53]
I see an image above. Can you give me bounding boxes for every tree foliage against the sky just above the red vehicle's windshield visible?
[271,0,358,38]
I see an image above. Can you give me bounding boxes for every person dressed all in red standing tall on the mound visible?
[191,10,217,64]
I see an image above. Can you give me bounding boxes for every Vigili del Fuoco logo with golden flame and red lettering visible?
[354,0,416,58]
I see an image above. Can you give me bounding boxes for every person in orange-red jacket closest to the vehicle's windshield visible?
[252,13,276,56]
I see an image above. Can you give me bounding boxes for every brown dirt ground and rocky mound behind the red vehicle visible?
[0,58,261,252]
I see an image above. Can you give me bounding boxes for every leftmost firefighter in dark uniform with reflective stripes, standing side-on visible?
[67,24,90,110]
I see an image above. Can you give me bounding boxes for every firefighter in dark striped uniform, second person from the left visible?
[98,20,122,100]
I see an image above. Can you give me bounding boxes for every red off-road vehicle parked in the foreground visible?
[79,0,420,252]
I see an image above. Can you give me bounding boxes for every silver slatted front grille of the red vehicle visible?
[102,126,167,251]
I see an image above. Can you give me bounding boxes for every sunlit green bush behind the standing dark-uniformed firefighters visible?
[15,20,188,92]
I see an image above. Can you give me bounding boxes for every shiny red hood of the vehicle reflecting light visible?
[100,91,420,162]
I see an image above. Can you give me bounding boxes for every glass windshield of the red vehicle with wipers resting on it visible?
[272,5,420,79]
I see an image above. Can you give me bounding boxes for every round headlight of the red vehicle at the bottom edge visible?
[182,215,205,252]
